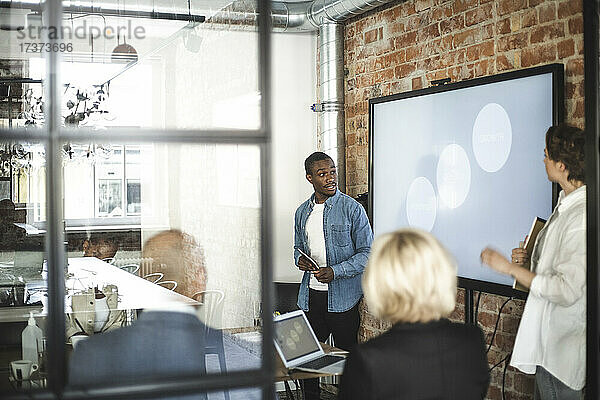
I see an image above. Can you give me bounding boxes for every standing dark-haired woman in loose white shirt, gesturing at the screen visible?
[481,125,586,400]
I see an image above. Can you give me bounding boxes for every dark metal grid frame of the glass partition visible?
[0,0,275,400]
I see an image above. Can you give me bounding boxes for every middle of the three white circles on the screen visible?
[436,144,471,208]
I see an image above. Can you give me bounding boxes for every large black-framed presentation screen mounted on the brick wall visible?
[369,64,564,297]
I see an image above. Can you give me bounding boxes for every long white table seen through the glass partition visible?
[0,257,200,322]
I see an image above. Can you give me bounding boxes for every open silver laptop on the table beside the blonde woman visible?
[274,310,346,375]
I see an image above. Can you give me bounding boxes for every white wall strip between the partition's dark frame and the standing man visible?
[271,34,317,282]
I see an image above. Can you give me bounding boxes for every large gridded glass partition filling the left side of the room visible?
[0,0,271,398]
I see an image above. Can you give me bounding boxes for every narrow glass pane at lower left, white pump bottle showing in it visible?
[0,141,48,394]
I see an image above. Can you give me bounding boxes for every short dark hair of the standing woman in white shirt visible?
[546,124,585,183]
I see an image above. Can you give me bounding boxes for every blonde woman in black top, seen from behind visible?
[339,229,490,400]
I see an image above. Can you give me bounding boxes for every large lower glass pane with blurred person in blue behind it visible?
[65,143,262,398]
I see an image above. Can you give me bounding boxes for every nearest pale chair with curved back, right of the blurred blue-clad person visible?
[192,289,229,400]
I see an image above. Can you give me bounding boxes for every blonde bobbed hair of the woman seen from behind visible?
[362,229,456,323]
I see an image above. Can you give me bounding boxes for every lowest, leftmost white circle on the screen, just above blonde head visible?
[406,176,437,232]
